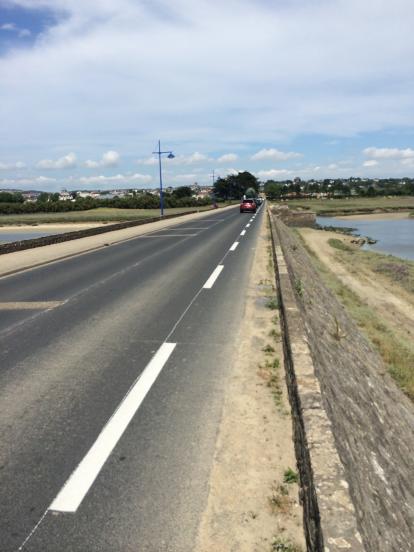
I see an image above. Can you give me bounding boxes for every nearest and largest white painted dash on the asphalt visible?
[49,343,176,512]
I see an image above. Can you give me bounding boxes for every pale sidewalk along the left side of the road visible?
[0,205,235,277]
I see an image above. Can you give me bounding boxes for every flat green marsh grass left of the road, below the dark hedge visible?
[0,205,211,226]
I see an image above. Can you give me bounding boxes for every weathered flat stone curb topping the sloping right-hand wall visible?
[268,211,365,552]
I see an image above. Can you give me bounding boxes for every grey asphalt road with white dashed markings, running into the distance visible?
[0,204,263,552]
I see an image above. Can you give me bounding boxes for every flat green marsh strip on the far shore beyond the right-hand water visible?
[288,196,414,216]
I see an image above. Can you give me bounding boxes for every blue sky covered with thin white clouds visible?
[0,0,414,191]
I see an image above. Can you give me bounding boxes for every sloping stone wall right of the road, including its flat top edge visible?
[271,209,414,552]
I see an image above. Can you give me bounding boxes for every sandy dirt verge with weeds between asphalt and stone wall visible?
[196,215,305,552]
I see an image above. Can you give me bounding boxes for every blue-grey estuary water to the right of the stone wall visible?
[316,217,414,261]
